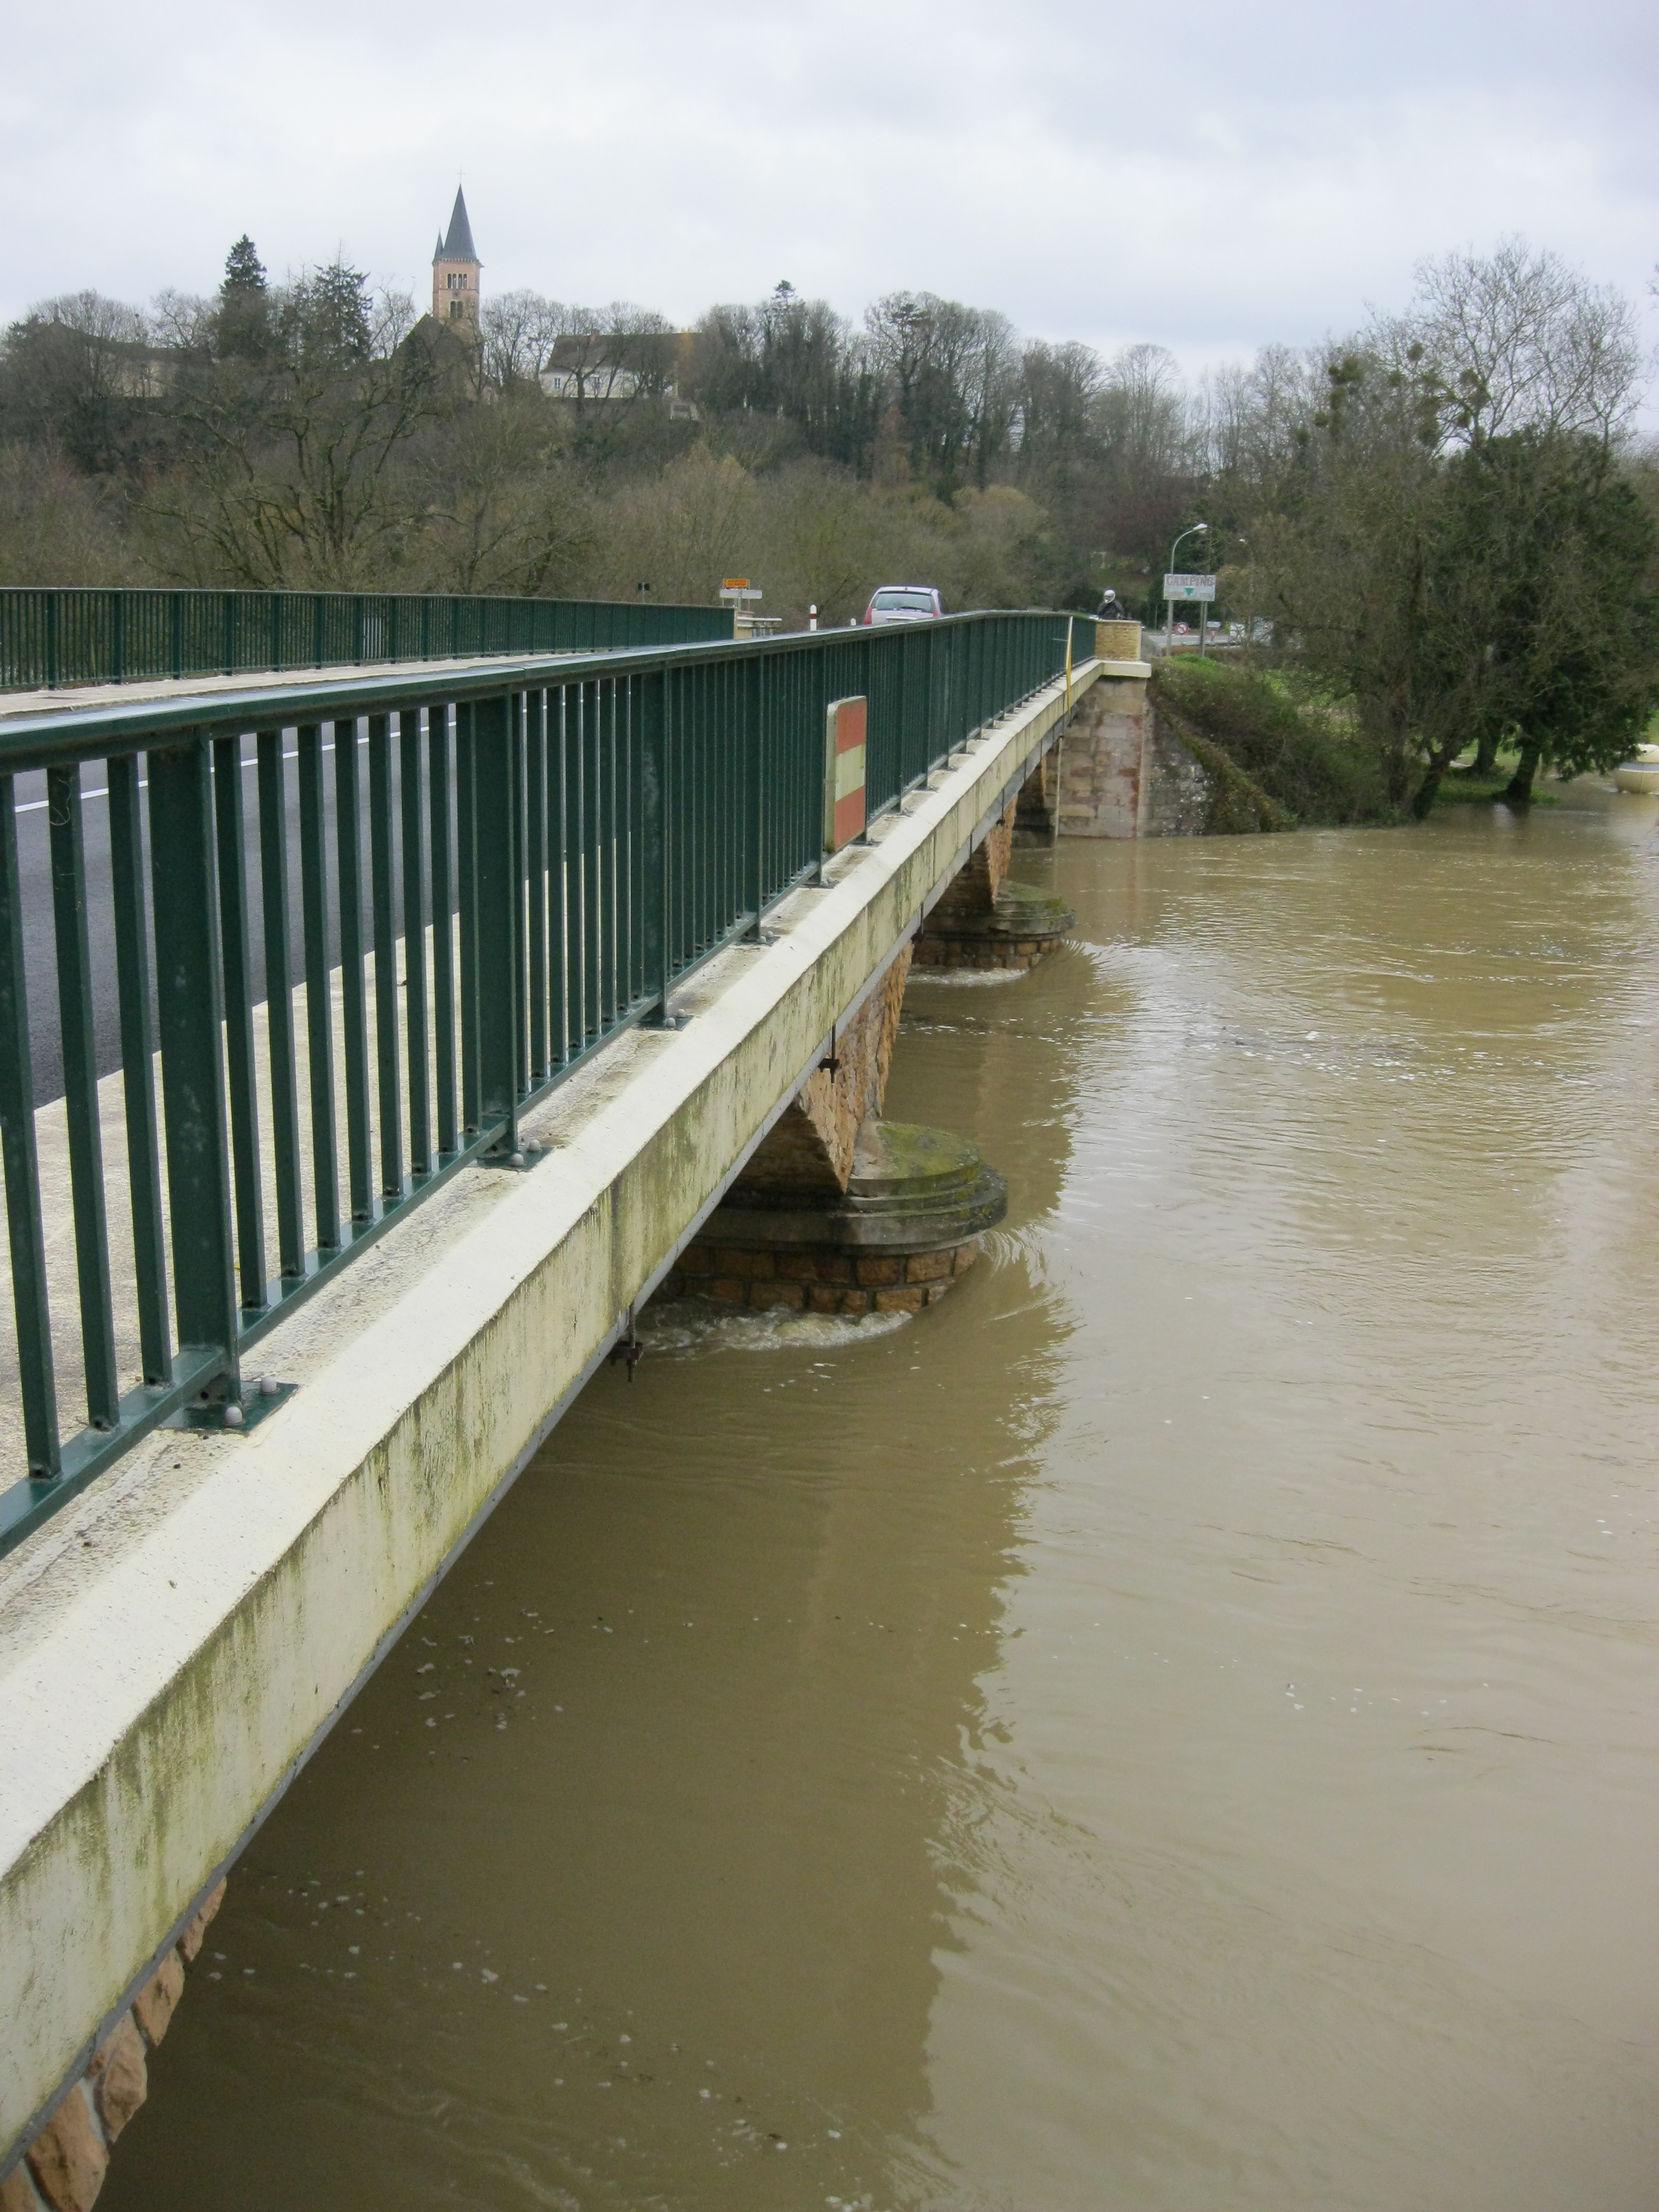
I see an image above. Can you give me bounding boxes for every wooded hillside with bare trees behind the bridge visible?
[0,236,1659,812]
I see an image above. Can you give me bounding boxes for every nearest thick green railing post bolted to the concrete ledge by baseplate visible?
[148,739,236,1393]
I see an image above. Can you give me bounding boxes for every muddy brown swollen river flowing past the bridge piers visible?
[104,788,1659,2212]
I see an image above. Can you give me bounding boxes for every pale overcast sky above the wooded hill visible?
[0,0,1659,394]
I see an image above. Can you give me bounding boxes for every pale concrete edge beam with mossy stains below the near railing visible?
[0,662,1146,2146]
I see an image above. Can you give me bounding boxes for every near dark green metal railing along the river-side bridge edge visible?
[0,612,1093,1546]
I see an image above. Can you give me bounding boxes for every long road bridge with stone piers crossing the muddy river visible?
[0,611,1153,2205]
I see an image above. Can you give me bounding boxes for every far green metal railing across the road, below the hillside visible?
[0,586,732,690]
